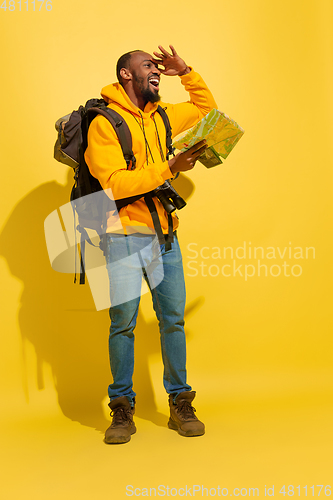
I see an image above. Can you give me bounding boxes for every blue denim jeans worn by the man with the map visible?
[106,234,192,405]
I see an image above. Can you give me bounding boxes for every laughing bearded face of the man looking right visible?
[130,52,161,102]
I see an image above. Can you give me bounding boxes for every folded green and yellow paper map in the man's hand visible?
[173,109,244,168]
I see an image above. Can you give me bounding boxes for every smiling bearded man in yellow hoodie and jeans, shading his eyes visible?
[85,45,217,444]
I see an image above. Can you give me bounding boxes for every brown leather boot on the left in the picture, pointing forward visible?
[104,396,136,444]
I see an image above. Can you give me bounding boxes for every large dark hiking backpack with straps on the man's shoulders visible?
[54,99,186,284]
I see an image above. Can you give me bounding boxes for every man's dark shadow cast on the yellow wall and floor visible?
[0,171,203,431]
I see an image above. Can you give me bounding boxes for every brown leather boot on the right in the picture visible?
[168,391,205,436]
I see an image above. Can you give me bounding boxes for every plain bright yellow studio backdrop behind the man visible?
[0,0,333,500]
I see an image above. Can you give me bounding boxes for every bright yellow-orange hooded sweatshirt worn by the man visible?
[85,69,217,234]
